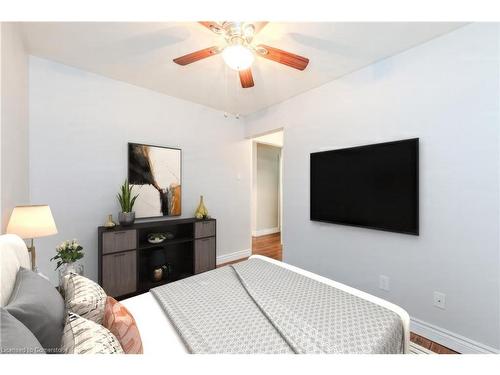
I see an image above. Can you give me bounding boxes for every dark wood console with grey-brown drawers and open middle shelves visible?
[98,218,217,299]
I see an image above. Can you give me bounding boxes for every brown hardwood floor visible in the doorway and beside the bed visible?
[217,233,459,354]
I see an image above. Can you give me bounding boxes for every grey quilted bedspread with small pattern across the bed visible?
[151,259,404,354]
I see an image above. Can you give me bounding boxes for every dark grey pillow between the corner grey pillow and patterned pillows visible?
[5,268,65,352]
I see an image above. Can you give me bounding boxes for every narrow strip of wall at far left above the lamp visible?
[0,22,29,233]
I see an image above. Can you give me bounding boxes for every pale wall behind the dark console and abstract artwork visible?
[29,57,251,281]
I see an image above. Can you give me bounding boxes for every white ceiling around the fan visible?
[19,22,464,115]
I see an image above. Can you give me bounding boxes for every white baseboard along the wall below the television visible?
[410,318,500,354]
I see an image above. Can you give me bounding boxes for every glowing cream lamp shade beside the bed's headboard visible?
[7,205,57,239]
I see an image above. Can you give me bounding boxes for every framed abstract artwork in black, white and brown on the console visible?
[128,143,182,218]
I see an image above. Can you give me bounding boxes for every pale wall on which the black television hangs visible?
[246,24,500,349]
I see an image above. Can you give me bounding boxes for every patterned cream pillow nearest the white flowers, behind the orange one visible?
[64,274,106,324]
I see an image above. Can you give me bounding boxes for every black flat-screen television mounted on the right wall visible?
[311,138,419,235]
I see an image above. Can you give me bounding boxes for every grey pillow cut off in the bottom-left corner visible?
[0,308,45,354]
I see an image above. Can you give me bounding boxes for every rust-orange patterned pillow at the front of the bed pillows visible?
[102,296,143,354]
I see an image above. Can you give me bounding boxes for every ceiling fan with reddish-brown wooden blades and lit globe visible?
[174,21,309,88]
